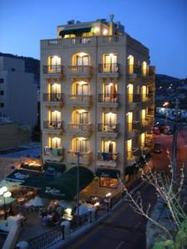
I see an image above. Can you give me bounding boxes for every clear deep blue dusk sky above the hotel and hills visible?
[0,0,187,78]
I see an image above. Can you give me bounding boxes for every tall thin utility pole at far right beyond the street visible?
[172,98,179,184]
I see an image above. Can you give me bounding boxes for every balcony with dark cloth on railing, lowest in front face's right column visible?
[97,152,119,168]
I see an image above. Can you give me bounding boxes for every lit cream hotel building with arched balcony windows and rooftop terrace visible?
[41,19,155,187]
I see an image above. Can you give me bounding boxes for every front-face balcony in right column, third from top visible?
[98,124,119,138]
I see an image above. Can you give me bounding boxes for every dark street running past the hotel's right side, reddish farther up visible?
[63,128,187,249]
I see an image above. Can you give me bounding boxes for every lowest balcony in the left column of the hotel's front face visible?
[44,146,64,160]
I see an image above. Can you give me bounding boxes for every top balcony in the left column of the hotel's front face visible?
[43,65,63,78]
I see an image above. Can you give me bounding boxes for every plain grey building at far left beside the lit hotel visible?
[0,53,39,127]
